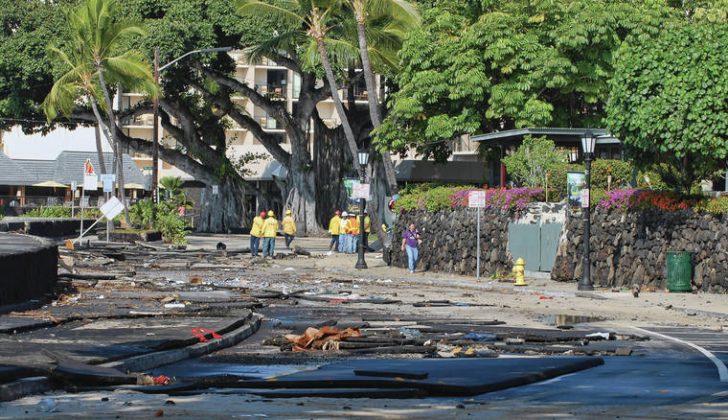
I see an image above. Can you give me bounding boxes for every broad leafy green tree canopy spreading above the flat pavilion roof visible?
[378,0,712,157]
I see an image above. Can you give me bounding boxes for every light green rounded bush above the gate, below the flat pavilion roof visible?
[503,136,566,187]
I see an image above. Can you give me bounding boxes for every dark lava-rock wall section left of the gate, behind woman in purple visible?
[392,209,515,276]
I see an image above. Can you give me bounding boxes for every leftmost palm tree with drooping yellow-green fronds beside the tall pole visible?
[43,0,158,223]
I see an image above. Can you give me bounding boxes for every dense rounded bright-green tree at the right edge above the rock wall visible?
[607,23,728,191]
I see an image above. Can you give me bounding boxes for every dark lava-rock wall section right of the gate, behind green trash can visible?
[551,208,728,293]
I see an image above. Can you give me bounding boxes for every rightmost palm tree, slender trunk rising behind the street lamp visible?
[348,0,419,195]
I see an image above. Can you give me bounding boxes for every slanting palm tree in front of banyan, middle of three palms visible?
[236,0,361,173]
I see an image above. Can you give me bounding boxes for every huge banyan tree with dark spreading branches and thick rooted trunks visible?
[0,0,382,231]
